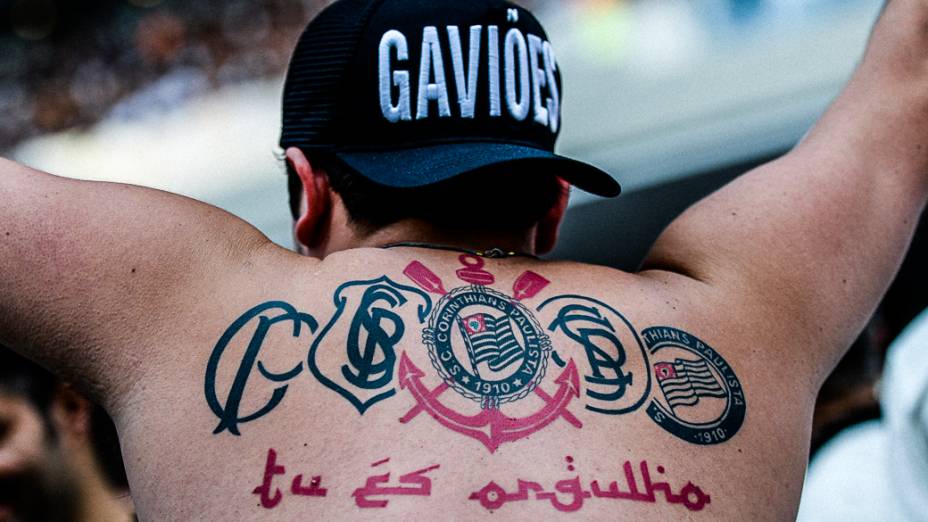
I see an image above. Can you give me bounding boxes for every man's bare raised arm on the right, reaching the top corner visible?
[643,0,928,379]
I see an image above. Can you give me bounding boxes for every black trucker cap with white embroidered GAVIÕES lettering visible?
[280,0,620,197]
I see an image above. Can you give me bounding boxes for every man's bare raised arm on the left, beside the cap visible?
[0,159,267,406]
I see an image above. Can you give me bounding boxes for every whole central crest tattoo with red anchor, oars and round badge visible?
[399,255,582,452]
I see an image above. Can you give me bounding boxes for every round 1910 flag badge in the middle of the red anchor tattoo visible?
[422,285,551,409]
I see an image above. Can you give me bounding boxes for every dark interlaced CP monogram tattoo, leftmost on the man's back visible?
[205,301,318,435]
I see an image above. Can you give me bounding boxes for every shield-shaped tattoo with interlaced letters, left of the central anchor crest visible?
[308,276,432,415]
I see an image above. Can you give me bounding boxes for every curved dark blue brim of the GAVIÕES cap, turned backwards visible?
[335,142,621,198]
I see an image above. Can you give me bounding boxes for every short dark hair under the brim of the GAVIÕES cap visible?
[287,152,564,235]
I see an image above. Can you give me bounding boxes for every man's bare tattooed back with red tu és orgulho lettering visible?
[109,247,792,520]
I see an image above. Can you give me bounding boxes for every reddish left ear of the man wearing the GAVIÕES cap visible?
[287,147,332,248]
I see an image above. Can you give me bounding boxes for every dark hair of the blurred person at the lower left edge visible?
[0,346,128,488]
